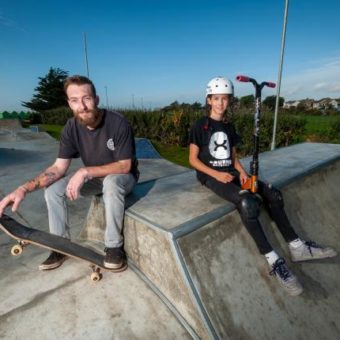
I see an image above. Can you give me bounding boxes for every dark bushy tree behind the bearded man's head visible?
[22,67,68,112]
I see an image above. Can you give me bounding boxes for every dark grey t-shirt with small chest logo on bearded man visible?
[58,110,139,178]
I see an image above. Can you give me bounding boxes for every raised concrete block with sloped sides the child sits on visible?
[83,143,340,339]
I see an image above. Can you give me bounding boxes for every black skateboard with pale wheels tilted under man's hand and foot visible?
[0,214,127,281]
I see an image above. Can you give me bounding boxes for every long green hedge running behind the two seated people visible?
[35,108,322,156]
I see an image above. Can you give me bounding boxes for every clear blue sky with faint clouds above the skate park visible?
[0,0,340,111]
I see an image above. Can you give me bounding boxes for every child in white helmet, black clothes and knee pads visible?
[189,77,337,295]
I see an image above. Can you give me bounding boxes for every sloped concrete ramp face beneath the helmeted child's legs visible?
[176,161,340,339]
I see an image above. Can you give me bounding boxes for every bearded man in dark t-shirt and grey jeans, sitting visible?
[0,75,139,270]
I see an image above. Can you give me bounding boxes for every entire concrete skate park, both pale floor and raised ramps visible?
[0,121,340,339]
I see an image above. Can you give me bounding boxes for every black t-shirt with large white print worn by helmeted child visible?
[190,117,240,184]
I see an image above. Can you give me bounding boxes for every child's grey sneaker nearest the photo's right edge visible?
[289,241,337,262]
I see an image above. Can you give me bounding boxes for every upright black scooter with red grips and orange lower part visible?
[236,75,276,193]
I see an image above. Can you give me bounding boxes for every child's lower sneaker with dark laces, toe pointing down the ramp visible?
[269,257,303,296]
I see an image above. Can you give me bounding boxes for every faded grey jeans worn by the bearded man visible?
[45,174,136,248]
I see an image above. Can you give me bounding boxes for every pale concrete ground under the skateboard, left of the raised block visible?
[0,127,191,340]
